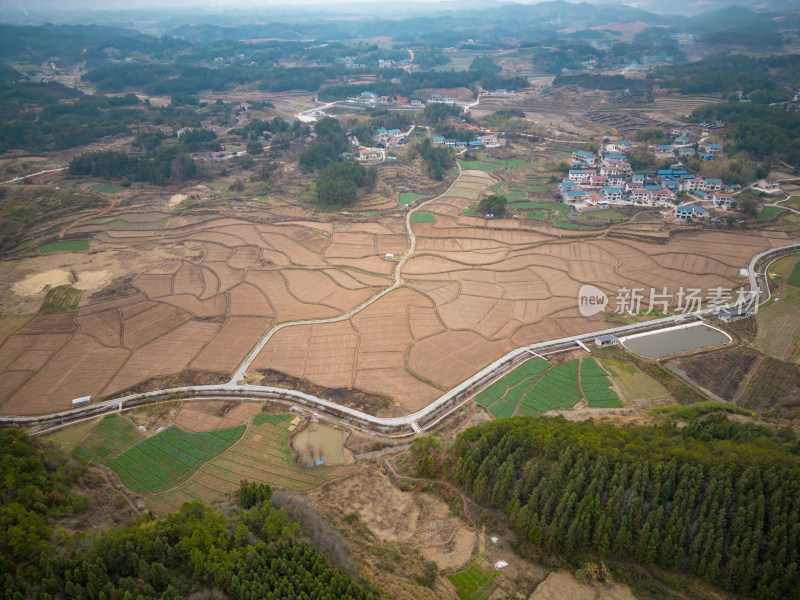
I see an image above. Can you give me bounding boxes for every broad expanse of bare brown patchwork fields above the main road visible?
[0,166,786,415]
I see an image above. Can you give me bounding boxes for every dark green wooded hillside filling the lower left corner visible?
[0,430,377,600]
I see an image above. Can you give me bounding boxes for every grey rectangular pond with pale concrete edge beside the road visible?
[620,323,731,358]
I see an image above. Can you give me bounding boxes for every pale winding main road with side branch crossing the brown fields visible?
[6,202,800,438]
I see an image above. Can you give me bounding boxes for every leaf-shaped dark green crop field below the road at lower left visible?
[108,425,245,494]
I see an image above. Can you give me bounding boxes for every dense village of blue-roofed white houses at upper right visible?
[558,139,739,221]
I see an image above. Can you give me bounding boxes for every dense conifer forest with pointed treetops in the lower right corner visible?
[414,415,800,599]
